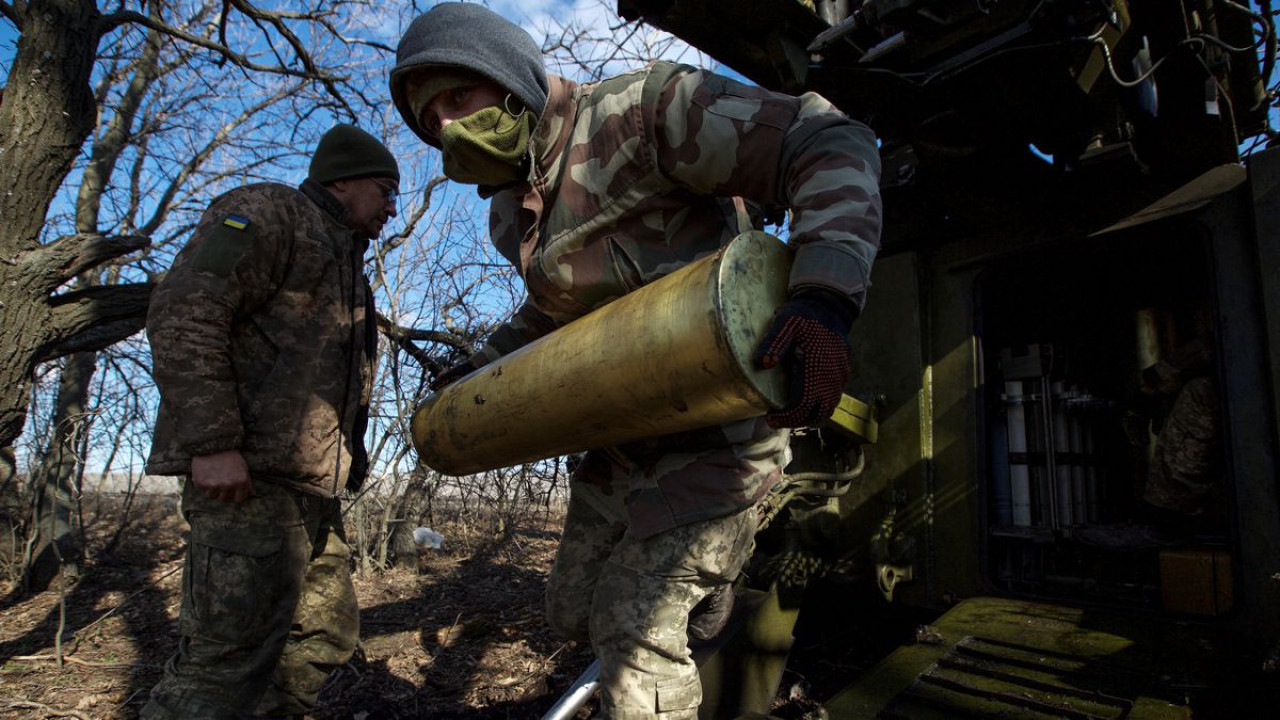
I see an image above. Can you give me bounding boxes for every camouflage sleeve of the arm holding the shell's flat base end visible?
[652,64,882,307]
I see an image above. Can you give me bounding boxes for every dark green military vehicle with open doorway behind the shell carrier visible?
[618,0,1280,720]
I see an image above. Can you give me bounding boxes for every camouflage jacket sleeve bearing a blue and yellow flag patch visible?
[147,188,291,456]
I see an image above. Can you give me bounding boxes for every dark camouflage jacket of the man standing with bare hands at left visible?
[147,181,376,496]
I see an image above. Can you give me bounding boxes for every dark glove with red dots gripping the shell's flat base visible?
[755,290,856,428]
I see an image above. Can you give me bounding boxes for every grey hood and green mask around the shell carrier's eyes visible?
[390,3,550,186]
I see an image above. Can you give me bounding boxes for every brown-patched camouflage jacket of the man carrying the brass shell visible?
[472,63,881,537]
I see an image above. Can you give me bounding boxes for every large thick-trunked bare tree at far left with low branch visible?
[0,0,384,489]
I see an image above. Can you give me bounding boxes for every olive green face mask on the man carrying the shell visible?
[440,106,538,186]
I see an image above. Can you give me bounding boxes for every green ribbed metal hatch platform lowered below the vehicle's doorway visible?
[824,598,1213,720]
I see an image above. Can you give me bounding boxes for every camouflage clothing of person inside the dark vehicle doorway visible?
[1143,378,1222,515]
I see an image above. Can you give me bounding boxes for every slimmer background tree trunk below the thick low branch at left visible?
[23,352,97,592]
